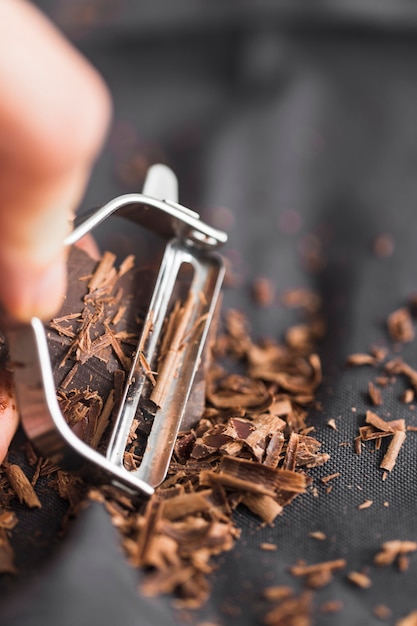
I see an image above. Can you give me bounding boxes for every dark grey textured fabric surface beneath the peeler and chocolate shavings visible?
[0,2,417,626]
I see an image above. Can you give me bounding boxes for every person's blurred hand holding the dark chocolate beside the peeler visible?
[0,0,111,461]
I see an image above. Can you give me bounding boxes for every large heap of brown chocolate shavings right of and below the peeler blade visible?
[95,302,329,607]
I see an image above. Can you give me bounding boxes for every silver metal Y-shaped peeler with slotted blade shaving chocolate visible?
[7,165,227,497]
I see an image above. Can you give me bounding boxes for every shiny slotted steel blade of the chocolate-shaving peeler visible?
[107,240,223,487]
